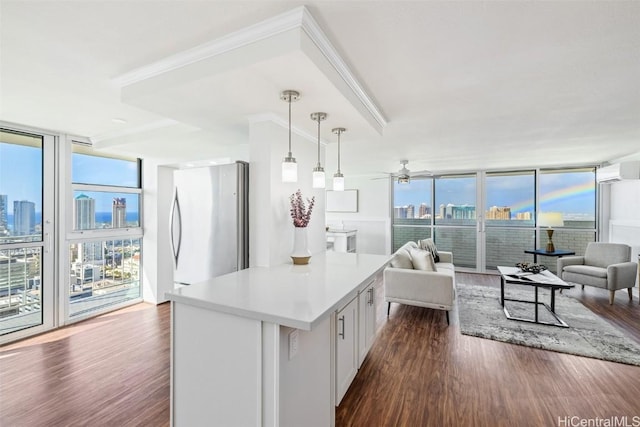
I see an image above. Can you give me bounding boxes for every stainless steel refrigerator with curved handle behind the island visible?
[171,162,249,286]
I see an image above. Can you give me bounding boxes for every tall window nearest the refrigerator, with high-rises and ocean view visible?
[66,143,142,319]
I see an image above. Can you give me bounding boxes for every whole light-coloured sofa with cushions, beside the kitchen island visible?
[383,242,455,324]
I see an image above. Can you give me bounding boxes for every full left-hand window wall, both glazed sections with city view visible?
[0,123,142,343]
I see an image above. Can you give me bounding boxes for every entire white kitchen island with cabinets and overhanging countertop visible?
[167,252,389,426]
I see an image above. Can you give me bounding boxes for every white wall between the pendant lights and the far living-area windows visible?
[326,176,391,255]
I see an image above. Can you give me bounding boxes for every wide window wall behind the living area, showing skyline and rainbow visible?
[392,167,597,271]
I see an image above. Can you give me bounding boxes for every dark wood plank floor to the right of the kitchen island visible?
[336,273,640,427]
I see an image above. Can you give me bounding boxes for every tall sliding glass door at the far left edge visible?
[0,129,55,343]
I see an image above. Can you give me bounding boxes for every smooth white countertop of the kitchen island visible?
[166,252,390,331]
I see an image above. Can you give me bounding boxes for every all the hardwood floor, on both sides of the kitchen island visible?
[0,273,640,427]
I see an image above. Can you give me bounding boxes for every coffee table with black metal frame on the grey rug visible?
[498,266,574,328]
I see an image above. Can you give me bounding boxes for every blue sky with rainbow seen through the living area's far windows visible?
[394,172,595,215]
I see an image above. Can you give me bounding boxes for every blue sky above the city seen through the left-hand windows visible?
[0,143,138,214]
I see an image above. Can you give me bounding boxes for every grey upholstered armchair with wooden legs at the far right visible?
[557,242,638,304]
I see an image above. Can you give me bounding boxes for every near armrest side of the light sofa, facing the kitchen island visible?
[383,267,455,306]
